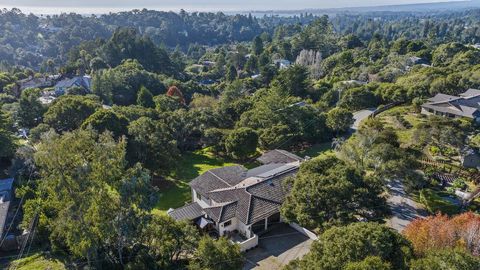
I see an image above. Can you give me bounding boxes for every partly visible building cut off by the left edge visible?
[0,178,16,250]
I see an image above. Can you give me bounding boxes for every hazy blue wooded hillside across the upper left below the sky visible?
[0,9,313,69]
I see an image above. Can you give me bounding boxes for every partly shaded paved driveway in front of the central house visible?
[243,224,313,270]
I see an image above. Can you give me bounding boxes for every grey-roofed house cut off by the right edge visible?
[422,89,480,122]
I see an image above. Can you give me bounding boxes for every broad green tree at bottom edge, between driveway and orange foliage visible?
[287,223,412,270]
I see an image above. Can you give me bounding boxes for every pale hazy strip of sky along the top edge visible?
[0,0,466,14]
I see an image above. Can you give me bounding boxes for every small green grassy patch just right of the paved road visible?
[419,189,460,215]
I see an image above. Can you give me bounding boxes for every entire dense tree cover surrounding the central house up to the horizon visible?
[0,5,480,270]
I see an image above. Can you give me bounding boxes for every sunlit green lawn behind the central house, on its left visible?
[153,149,236,214]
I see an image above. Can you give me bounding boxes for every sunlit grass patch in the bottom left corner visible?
[8,253,67,270]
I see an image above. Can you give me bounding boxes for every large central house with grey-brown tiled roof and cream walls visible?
[168,150,303,251]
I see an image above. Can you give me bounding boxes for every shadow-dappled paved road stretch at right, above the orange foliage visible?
[387,180,428,232]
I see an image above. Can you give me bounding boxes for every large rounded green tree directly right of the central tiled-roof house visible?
[281,155,386,229]
